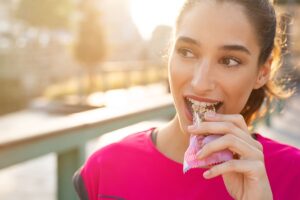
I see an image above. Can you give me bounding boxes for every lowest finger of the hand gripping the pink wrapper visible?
[203,160,265,181]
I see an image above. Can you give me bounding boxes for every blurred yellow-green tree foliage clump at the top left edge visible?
[15,0,75,29]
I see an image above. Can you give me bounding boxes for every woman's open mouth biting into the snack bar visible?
[185,97,223,120]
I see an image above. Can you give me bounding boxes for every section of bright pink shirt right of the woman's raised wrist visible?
[257,135,300,199]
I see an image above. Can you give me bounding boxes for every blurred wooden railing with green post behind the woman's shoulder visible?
[0,95,175,200]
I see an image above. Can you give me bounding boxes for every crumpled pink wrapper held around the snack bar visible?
[183,110,233,173]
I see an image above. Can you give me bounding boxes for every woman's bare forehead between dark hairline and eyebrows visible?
[176,0,259,51]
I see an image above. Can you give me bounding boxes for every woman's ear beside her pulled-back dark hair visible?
[253,56,273,89]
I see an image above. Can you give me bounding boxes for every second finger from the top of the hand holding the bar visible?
[189,122,262,151]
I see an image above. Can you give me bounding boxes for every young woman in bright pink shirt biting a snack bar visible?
[74,0,300,200]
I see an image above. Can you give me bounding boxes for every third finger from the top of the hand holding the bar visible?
[197,134,264,161]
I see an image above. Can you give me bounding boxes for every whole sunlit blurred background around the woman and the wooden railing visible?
[0,0,300,200]
